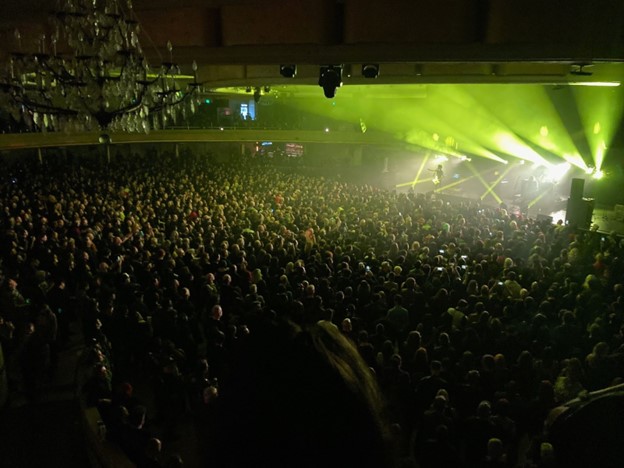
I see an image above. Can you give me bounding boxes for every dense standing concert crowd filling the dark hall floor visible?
[0,147,624,468]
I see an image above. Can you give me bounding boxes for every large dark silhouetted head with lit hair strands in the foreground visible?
[216,322,390,468]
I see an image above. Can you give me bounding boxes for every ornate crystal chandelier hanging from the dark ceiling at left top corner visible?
[0,0,201,133]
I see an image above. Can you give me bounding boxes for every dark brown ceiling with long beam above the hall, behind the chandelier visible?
[0,0,624,86]
